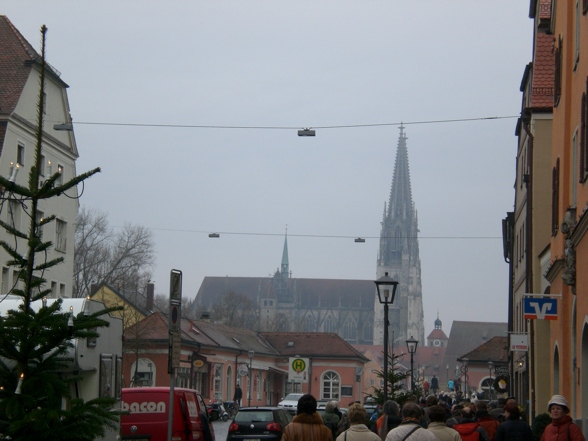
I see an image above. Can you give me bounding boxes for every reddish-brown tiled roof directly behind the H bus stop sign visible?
[261,332,368,362]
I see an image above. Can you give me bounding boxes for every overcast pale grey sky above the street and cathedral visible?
[0,0,532,334]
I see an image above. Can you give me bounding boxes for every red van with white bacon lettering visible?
[120,387,214,441]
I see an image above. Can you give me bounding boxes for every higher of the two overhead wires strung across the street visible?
[52,115,520,130]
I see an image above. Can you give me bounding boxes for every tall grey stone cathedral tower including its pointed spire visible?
[374,126,425,346]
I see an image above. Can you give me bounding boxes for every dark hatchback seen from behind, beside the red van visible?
[227,407,292,441]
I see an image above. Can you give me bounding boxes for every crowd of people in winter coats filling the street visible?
[282,394,585,441]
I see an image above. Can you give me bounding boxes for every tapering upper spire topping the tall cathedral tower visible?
[388,124,414,219]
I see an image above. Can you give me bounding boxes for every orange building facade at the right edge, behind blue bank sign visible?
[513,0,588,426]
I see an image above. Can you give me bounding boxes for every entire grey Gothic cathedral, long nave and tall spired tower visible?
[196,127,425,345]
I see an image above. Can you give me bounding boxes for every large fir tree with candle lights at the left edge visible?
[0,26,118,441]
